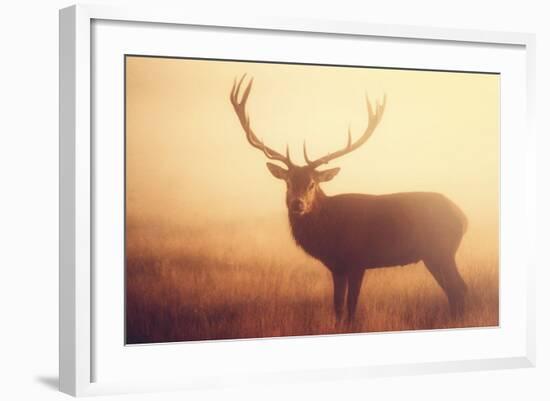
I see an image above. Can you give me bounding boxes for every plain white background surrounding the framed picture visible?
[0,0,550,400]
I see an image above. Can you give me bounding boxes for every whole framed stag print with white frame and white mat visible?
[60,6,535,395]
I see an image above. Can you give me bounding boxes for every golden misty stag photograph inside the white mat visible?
[124,54,500,345]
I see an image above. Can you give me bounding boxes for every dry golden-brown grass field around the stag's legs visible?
[126,216,499,344]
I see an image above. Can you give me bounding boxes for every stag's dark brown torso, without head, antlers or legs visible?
[291,192,466,268]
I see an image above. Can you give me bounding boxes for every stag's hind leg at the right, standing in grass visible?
[424,256,467,317]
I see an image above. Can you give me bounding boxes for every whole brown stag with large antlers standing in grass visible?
[230,74,468,322]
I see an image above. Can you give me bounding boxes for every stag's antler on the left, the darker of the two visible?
[230,74,294,168]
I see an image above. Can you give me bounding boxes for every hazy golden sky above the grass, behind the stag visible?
[126,57,500,231]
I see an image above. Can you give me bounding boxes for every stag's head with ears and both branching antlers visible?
[230,75,386,216]
